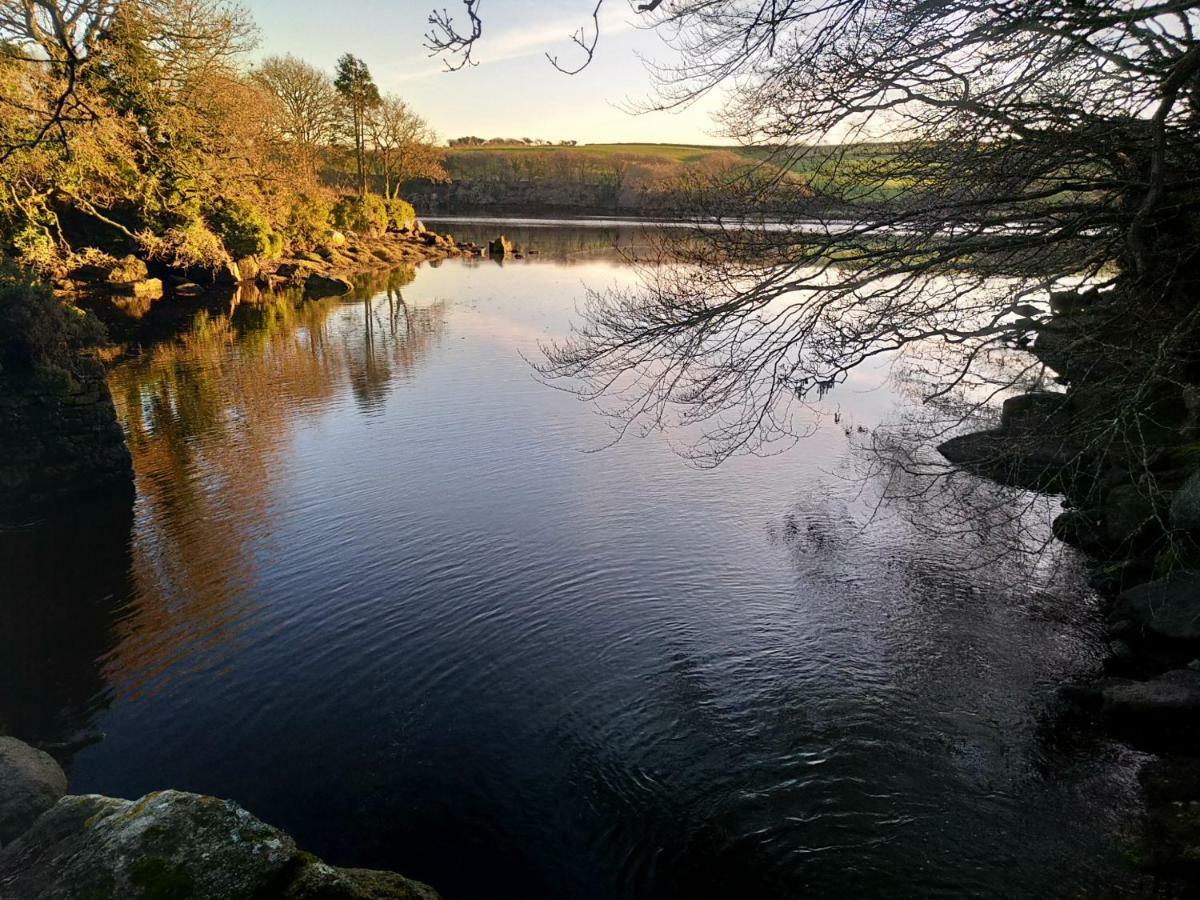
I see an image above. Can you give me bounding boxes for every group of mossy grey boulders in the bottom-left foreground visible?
[0,737,438,900]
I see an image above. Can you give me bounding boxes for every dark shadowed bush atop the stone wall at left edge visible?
[0,265,104,372]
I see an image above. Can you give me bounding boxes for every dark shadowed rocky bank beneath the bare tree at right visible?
[938,290,1200,896]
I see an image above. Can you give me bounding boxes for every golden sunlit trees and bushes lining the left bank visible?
[0,0,445,281]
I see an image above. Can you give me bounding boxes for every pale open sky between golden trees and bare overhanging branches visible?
[242,0,727,144]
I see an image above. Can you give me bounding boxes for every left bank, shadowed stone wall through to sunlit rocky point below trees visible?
[0,221,486,511]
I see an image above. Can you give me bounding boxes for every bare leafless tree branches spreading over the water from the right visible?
[432,0,1200,468]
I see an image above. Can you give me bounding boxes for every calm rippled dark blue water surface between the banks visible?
[0,226,1134,900]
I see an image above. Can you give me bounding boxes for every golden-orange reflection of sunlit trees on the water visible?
[100,269,445,692]
